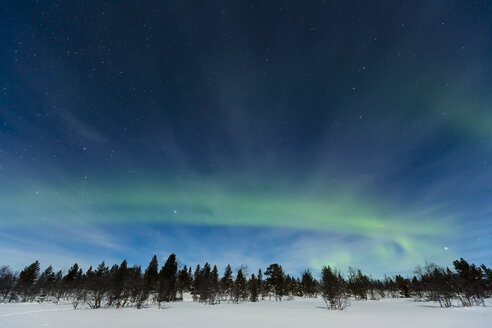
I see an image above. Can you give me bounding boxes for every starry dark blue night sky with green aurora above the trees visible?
[0,0,492,276]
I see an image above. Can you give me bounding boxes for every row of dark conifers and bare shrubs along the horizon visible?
[0,254,492,310]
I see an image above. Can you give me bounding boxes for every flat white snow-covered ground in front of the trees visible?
[0,298,492,328]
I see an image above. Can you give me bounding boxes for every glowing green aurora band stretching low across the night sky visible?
[1,180,459,269]
